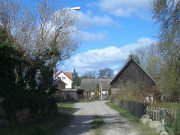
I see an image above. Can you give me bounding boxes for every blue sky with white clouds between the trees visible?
[21,0,157,75]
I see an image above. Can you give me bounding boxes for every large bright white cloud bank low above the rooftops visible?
[60,38,155,74]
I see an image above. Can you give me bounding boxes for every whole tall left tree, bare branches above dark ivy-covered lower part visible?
[0,0,78,116]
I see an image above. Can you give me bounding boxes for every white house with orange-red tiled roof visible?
[55,72,73,89]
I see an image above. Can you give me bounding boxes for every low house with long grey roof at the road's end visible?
[80,78,111,96]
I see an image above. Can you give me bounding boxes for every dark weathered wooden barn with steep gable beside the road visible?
[109,57,155,100]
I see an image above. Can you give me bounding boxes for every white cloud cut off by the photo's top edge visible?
[89,0,150,18]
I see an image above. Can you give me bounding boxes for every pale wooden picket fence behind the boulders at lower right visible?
[146,106,177,125]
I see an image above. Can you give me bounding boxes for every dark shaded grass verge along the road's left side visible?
[0,113,72,135]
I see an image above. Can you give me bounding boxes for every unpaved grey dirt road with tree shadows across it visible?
[56,101,138,135]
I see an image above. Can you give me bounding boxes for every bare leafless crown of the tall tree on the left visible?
[0,0,78,65]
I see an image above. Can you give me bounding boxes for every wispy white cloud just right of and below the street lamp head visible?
[77,11,120,28]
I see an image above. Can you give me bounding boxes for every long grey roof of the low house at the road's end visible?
[80,79,111,92]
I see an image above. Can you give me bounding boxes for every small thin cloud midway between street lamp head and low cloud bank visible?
[75,31,107,42]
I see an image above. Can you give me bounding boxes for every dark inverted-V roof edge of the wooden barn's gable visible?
[109,57,155,85]
